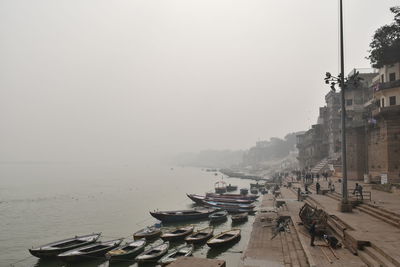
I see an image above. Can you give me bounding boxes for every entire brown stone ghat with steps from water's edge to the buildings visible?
[241,177,400,267]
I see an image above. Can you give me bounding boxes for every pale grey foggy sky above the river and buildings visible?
[0,0,399,161]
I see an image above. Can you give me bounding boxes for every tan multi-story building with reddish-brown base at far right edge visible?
[367,63,400,182]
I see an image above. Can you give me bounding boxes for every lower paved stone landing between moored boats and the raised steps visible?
[241,183,368,267]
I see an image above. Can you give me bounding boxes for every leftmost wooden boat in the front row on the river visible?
[29,233,101,259]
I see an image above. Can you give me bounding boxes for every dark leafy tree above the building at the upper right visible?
[367,6,400,68]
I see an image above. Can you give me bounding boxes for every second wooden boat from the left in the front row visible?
[57,238,123,262]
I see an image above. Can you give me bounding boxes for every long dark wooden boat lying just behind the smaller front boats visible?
[150,208,216,222]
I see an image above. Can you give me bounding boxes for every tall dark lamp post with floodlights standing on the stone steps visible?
[325,0,358,212]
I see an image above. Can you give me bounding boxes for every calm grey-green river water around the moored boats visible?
[0,163,260,267]
